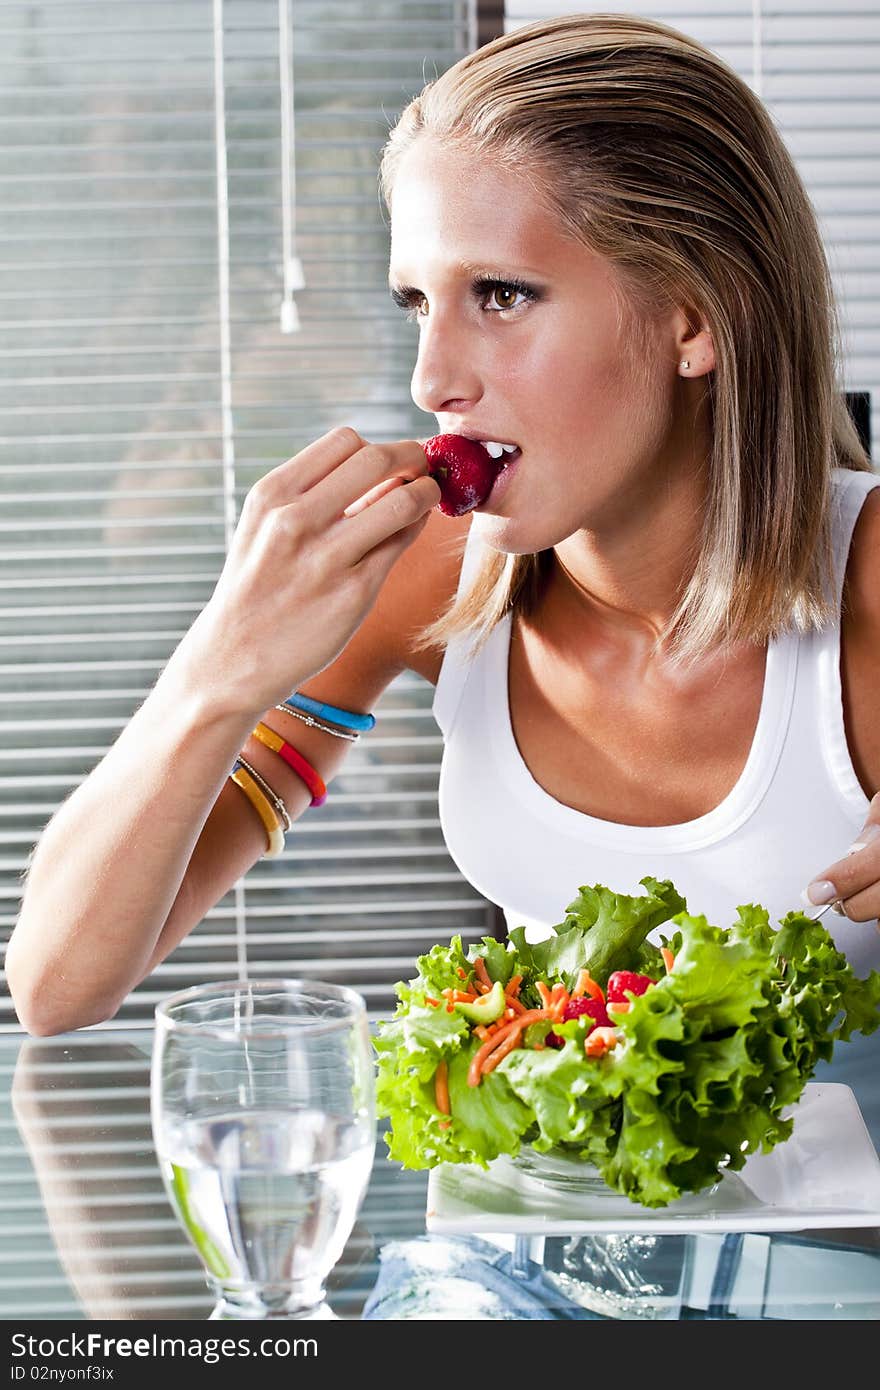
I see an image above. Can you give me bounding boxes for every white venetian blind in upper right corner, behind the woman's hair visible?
[505,0,880,441]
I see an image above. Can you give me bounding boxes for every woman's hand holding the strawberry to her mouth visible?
[170,427,439,716]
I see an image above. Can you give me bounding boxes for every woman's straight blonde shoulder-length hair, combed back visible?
[380,14,870,660]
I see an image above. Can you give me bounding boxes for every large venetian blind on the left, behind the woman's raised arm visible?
[0,0,489,1030]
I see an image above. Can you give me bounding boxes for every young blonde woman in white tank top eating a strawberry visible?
[7,15,880,1033]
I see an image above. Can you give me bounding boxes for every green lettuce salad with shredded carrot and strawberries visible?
[374,877,880,1207]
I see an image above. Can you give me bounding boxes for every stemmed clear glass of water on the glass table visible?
[152,980,375,1318]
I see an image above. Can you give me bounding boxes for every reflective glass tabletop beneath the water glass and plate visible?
[0,1029,880,1321]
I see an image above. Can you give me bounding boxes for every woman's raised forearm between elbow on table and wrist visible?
[7,653,259,1033]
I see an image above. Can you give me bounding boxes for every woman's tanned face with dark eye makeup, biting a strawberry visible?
[389,135,694,553]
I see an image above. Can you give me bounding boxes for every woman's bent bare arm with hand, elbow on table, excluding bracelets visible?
[6,430,439,1034]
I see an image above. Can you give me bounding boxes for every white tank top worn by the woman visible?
[432,468,880,974]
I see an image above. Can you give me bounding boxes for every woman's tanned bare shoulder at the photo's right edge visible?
[841,488,880,796]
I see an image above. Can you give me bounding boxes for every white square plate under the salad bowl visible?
[427,1083,880,1236]
